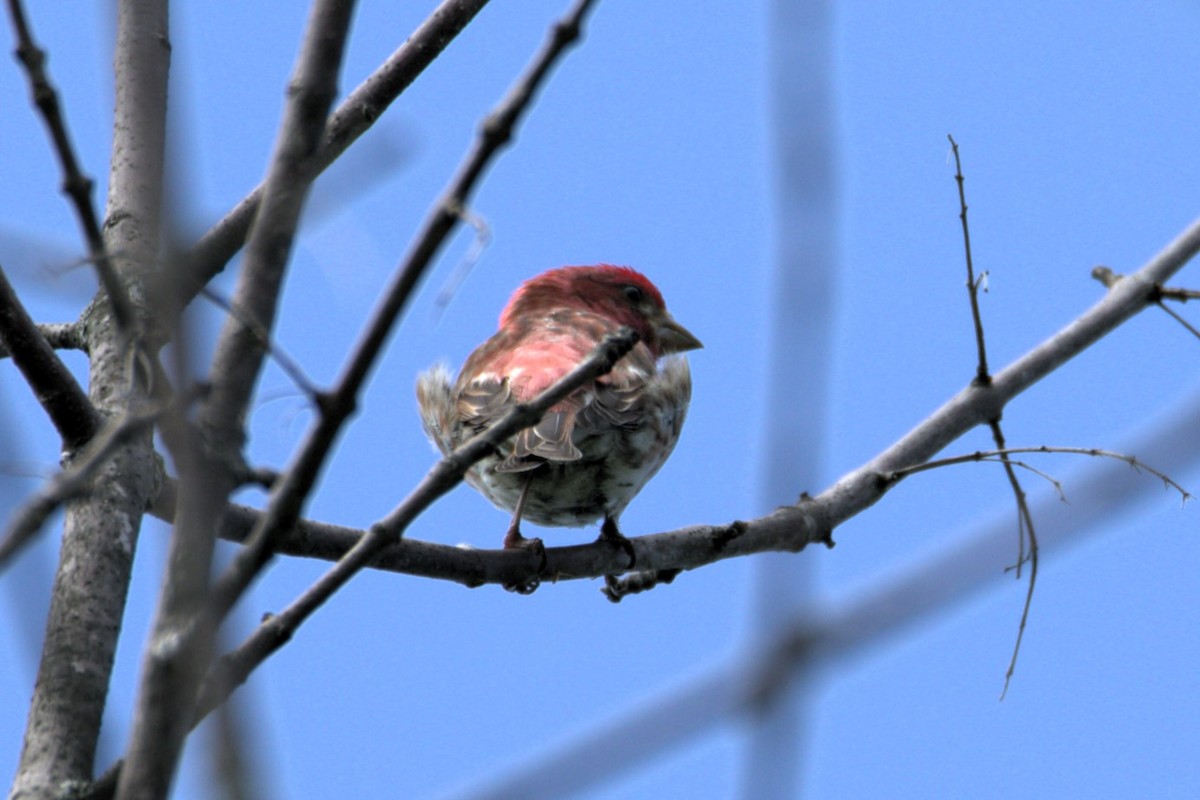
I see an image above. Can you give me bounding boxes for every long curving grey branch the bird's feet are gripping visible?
[145,215,1200,587]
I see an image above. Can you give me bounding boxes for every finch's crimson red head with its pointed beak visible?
[500,264,703,355]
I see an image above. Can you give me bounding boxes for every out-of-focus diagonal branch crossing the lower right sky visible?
[454,398,1200,800]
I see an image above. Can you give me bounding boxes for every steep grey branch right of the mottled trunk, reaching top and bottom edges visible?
[116,0,354,800]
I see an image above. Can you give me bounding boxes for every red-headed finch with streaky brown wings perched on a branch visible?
[416,264,702,561]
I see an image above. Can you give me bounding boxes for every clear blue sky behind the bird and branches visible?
[0,0,1200,798]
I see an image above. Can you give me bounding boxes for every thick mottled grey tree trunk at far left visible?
[12,0,169,796]
